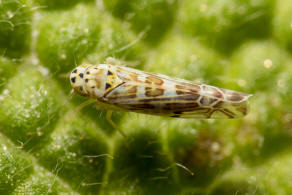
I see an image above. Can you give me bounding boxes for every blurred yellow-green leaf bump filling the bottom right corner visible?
[208,153,292,195]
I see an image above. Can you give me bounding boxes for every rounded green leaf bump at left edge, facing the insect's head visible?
[0,67,64,150]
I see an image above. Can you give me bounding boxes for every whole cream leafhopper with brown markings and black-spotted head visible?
[70,64,251,122]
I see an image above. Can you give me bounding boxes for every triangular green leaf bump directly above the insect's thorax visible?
[85,13,146,66]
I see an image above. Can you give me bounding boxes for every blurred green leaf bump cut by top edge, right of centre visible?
[181,0,274,54]
